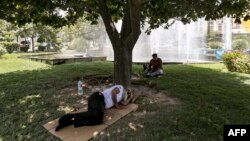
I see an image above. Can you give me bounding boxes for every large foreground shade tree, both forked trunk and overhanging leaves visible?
[0,0,250,87]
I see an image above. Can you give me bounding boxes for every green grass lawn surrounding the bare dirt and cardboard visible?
[0,54,250,141]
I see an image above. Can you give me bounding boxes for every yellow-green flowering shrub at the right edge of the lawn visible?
[223,51,250,73]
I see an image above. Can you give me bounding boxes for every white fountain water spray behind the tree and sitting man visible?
[106,19,207,62]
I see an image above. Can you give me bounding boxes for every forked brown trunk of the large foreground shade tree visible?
[99,0,142,88]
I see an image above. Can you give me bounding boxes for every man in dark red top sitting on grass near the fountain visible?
[143,53,163,77]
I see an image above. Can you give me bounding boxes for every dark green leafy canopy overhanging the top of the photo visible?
[0,0,250,29]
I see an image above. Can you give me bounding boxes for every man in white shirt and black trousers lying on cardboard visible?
[55,85,133,131]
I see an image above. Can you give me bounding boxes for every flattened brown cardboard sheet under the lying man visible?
[43,103,138,141]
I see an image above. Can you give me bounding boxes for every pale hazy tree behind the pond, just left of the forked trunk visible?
[60,18,106,52]
